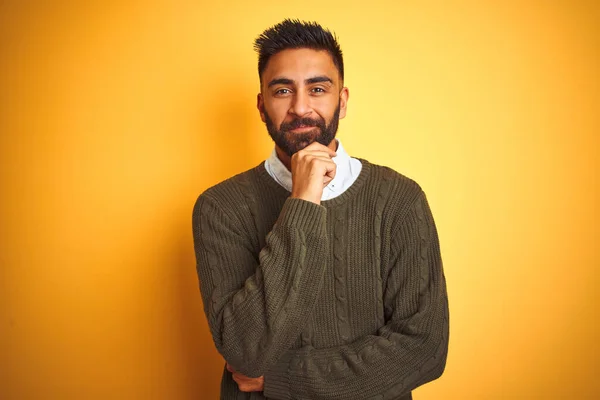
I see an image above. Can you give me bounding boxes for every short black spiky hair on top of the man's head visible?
[254,18,344,82]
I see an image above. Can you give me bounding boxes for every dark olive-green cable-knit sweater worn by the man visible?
[192,160,448,400]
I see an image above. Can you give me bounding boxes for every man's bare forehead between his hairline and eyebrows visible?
[263,49,339,83]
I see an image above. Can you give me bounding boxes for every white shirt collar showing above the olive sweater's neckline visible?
[265,139,362,201]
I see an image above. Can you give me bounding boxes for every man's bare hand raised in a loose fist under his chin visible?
[291,142,336,204]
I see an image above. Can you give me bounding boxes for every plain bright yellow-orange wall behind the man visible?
[0,0,600,400]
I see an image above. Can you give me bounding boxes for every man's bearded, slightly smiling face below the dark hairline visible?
[257,49,348,156]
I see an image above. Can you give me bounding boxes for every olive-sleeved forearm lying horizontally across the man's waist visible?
[265,300,448,400]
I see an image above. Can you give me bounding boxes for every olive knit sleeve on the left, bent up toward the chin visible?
[192,194,328,377]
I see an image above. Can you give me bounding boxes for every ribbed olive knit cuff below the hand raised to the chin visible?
[279,197,327,235]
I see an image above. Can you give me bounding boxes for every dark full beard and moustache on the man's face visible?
[262,102,340,157]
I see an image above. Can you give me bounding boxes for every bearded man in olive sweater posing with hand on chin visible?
[193,20,448,400]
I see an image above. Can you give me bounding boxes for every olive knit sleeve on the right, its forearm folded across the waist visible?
[265,192,449,400]
